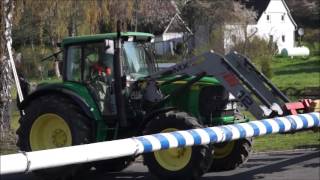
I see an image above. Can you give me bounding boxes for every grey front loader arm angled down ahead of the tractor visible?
[148,52,287,119]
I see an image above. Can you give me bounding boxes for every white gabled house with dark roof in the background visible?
[224,0,297,54]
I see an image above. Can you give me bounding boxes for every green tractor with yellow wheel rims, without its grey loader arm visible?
[17,32,252,179]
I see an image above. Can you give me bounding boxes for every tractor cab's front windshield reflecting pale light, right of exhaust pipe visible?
[123,41,155,79]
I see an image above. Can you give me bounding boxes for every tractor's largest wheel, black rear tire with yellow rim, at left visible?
[17,95,92,180]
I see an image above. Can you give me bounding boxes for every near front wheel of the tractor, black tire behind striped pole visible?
[143,112,212,180]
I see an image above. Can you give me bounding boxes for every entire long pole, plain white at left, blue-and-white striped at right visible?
[0,112,320,175]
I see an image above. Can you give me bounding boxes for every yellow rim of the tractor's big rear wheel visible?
[29,113,72,151]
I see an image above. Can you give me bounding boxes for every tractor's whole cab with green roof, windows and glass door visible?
[62,32,157,116]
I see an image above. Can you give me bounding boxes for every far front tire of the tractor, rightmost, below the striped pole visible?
[210,138,252,171]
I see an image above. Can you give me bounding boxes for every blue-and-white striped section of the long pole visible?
[137,113,320,153]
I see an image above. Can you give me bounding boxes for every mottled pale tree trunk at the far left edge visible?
[0,0,14,140]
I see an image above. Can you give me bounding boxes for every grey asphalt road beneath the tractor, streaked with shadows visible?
[0,150,320,180]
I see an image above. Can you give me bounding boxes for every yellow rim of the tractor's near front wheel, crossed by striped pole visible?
[154,128,192,171]
